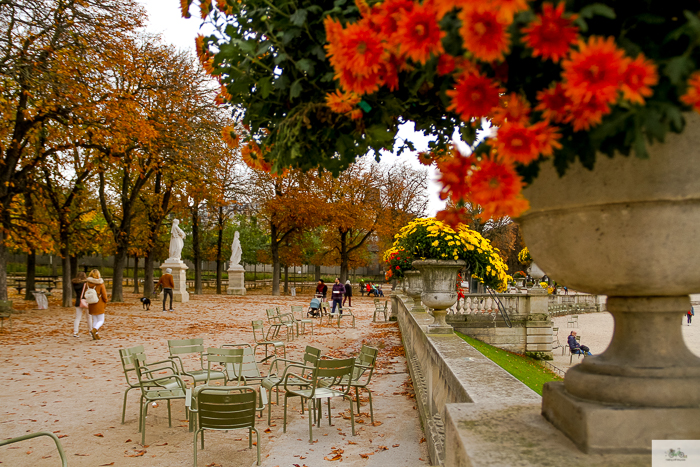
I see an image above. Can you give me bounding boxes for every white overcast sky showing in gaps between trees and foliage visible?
[141,0,444,216]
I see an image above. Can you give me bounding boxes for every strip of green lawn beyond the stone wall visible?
[456,332,562,396]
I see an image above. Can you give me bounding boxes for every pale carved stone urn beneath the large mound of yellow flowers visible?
[413,259,467,334]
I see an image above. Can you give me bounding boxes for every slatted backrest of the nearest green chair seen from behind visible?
[196,386,257,430]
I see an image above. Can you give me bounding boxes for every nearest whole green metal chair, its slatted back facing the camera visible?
[188,386,267,467]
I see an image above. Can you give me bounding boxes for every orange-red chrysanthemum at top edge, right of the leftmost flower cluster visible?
[396,5,445,64]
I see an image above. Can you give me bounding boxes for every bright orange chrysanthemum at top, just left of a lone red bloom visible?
[459,9,510,62]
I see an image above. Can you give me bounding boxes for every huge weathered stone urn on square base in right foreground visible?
[518,113,700,452]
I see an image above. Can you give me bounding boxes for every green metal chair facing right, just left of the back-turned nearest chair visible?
[134,354,191,444]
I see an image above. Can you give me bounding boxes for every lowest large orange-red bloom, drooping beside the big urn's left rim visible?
[469,158,523,207]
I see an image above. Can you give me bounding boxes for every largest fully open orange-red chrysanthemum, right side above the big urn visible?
[562,36,625,103]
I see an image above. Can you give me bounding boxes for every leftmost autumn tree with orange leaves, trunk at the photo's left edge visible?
[0,0,143,299]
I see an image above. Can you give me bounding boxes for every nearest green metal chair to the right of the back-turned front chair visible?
[283,358,355,443]
